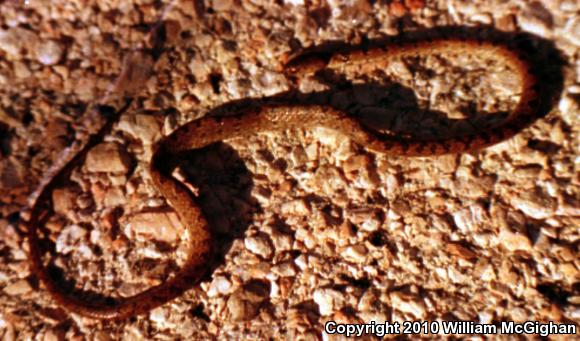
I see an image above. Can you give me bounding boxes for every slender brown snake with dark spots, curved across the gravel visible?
[21,38,540,320]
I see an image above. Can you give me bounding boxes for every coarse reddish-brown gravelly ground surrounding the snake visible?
[0,0,580,340]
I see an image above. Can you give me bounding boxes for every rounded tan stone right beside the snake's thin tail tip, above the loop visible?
[85,142,131,173]
